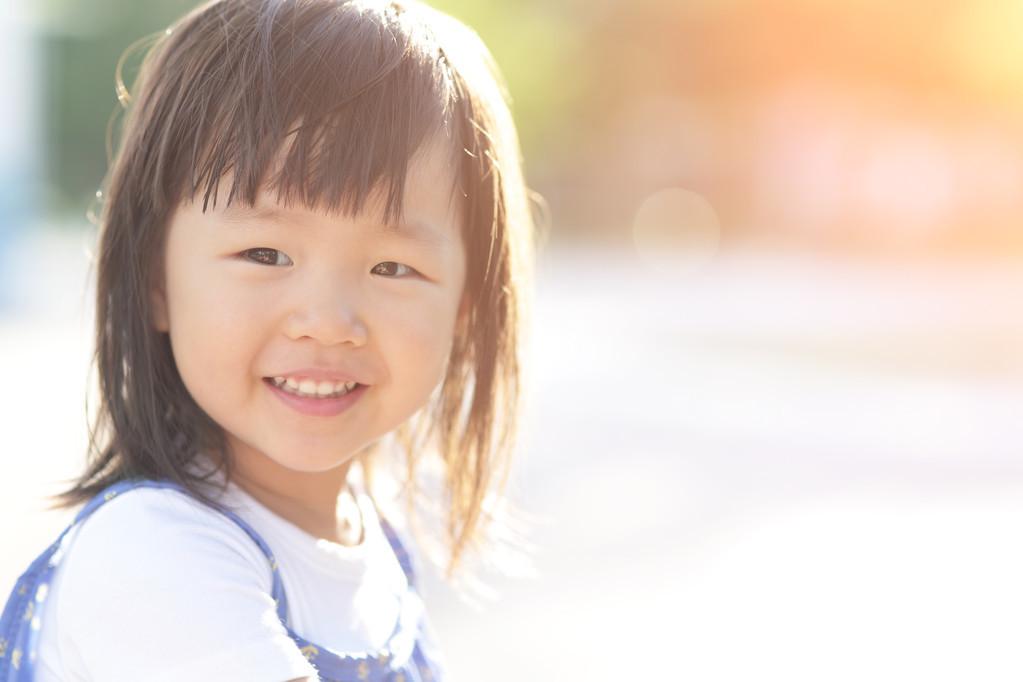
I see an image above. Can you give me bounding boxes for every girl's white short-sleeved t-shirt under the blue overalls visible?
[36,474,408,682]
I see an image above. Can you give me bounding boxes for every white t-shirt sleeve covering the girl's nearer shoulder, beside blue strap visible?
[51,488,317,680]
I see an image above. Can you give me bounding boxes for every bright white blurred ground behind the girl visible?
[0,232,1023,682]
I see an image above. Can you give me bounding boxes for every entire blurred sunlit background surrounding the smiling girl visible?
[6,0,1023,682]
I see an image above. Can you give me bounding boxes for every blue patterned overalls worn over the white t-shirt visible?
[0,480,443,682]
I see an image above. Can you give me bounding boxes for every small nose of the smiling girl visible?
[284,283,368,346]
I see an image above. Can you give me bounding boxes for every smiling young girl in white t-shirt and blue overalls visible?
[0,0,533,682]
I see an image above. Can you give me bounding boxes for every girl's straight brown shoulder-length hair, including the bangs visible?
[54,0,534,577]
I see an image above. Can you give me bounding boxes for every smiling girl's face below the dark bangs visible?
[153,138,465,480]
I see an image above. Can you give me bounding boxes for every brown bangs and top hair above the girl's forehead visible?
[154,0,461,222]
